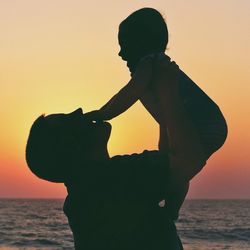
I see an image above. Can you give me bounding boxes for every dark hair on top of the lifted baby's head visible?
[119,8,168,51]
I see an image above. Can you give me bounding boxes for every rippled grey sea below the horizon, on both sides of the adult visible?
[0,199,250,250]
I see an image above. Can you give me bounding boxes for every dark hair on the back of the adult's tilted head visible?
[26,115,70,182]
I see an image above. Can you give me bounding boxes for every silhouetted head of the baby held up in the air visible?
[118,8,168,73]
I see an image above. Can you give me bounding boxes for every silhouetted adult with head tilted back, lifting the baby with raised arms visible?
[26,61,205,250]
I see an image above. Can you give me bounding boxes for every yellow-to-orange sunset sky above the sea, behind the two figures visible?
[0,0,250,198]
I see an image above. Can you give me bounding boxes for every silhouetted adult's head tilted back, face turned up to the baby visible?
[26,109,111,182]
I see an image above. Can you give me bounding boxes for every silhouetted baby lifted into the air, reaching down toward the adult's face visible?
[87,8,227,219]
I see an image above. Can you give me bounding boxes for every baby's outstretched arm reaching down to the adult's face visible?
[87,59,152,120]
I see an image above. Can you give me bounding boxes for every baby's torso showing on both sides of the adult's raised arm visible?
[140,70,227,157]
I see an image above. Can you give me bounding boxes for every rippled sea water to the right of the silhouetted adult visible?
[176,200,250,250]
